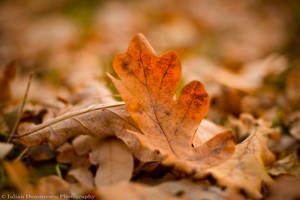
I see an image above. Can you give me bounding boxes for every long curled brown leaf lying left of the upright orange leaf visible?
[18,103,134,149]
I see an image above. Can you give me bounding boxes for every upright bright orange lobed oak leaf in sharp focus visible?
[109,34,234,162]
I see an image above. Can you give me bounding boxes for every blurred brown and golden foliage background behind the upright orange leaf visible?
[0,0,300,124]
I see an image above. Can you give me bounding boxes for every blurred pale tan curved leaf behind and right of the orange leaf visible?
[184,54,287,93]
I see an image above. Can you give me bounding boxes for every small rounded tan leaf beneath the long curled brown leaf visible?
[95,139,134,186]
